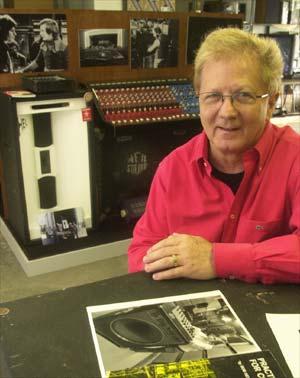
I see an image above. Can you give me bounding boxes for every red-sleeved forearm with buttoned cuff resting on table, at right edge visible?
[213,234,300,284]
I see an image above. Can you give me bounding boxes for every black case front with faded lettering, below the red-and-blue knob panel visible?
[99,120,201,213]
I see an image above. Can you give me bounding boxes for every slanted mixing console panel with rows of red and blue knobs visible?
[89,79,199,126]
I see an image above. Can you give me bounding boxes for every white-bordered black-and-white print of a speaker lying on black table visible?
[87,291,260,377]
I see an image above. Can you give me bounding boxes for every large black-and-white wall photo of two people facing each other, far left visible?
[0,13,68,73]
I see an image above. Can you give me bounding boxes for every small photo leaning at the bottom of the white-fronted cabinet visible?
[39,207,87,245]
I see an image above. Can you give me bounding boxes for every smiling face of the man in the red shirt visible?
[199,59,272,156]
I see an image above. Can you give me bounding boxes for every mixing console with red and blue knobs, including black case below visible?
[89,79,201,223]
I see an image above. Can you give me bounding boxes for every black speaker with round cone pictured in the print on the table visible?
[94,303,193,351]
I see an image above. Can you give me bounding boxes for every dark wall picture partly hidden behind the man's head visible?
[186,16,243,64]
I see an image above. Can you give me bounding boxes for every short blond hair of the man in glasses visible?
[194,28,283,95]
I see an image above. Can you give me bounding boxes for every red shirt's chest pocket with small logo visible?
[236,218,285,243]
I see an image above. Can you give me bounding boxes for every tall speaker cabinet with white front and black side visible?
[0,91,95,255]
